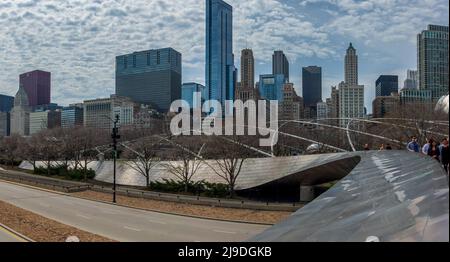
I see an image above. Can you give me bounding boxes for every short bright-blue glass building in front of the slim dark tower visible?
[258,74,286,103]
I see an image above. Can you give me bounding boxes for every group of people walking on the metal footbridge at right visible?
[407,136,450,173]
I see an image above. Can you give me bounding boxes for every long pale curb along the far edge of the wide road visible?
[0,179,275,226]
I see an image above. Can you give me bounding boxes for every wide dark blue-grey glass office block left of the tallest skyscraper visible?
[116,48,182,113]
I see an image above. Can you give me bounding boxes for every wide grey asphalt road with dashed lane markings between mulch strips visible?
[0,181,268,242]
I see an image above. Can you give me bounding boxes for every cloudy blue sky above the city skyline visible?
[0,0,449,111]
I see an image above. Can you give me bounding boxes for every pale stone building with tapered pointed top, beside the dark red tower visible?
[11,86,31,136]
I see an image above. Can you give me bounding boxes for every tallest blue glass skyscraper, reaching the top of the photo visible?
[205,0,237,108]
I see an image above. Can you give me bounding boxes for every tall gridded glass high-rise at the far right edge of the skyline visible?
[417,25,449,101]
